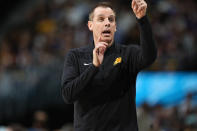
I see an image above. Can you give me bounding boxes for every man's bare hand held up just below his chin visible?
[93,38,108,67]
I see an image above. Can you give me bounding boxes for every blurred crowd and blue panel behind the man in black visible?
[0,0,197,131]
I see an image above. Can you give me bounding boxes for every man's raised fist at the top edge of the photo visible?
[131,0,147,19]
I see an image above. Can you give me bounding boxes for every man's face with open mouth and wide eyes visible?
[88,7,116,46]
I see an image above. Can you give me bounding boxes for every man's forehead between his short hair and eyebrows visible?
[94,7,115,17]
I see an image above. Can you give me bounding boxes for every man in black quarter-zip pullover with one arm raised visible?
[61,0,156,131]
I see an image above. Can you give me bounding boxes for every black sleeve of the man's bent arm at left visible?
[61,51,98,104]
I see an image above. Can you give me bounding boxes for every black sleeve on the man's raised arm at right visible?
[128,16,157,73]
